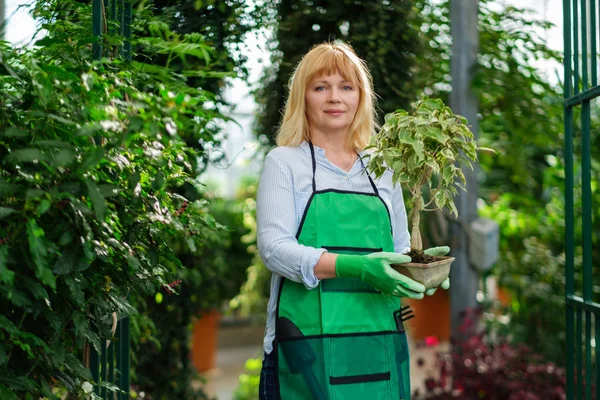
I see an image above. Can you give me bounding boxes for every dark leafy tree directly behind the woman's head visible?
[256,0,422,143]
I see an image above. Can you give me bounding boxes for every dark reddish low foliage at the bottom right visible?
[416,310,566,400]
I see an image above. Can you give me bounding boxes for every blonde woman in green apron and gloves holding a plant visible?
[257,42,449,400]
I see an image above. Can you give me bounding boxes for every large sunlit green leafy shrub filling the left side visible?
[0,1,239,399]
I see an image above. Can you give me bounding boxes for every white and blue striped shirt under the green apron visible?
[256,141,410,353]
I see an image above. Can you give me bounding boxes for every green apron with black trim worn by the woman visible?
[274,143,410,400]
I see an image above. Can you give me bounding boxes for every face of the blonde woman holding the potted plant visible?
[305,72,360,138]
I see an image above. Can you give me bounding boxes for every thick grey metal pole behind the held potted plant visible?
[450,0,479,338]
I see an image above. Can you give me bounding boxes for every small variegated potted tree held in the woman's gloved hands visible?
[367,98,483,288]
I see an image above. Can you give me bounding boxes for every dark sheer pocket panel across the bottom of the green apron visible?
[277,332,410,400]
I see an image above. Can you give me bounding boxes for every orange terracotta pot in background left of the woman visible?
[192,310,220,372]
